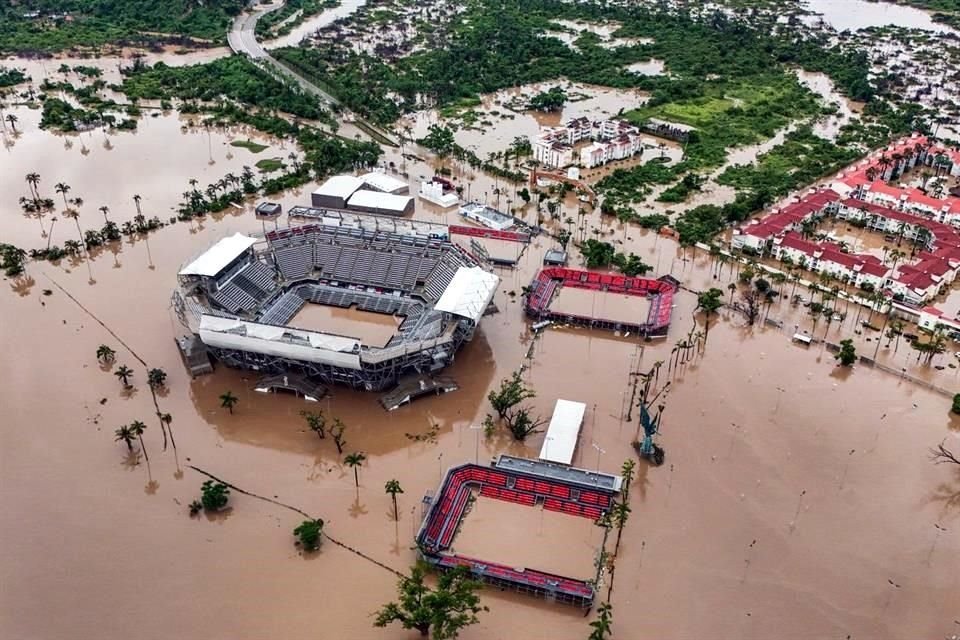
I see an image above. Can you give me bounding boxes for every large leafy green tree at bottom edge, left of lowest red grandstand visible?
[373,565,488,640]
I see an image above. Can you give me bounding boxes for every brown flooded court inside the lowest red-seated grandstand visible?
[451,496,603,580]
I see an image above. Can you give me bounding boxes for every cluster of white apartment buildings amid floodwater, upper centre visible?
[533,118,644,168]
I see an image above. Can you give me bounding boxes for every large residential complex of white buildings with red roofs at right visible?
[731,135,960,327]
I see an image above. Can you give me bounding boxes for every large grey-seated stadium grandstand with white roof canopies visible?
[173,215,500,391]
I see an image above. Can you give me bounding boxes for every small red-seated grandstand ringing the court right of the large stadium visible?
[526,267,676,336]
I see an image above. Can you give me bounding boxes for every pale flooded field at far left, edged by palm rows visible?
[0,107,299,248]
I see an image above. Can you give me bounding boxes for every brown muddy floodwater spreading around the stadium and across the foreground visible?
[0,196,960,640]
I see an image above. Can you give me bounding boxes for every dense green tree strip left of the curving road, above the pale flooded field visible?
[123,56,328,120]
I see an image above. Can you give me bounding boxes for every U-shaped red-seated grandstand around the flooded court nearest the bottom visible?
[416,456,620,608]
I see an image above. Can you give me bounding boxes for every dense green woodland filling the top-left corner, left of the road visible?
[0,0,246,54]
